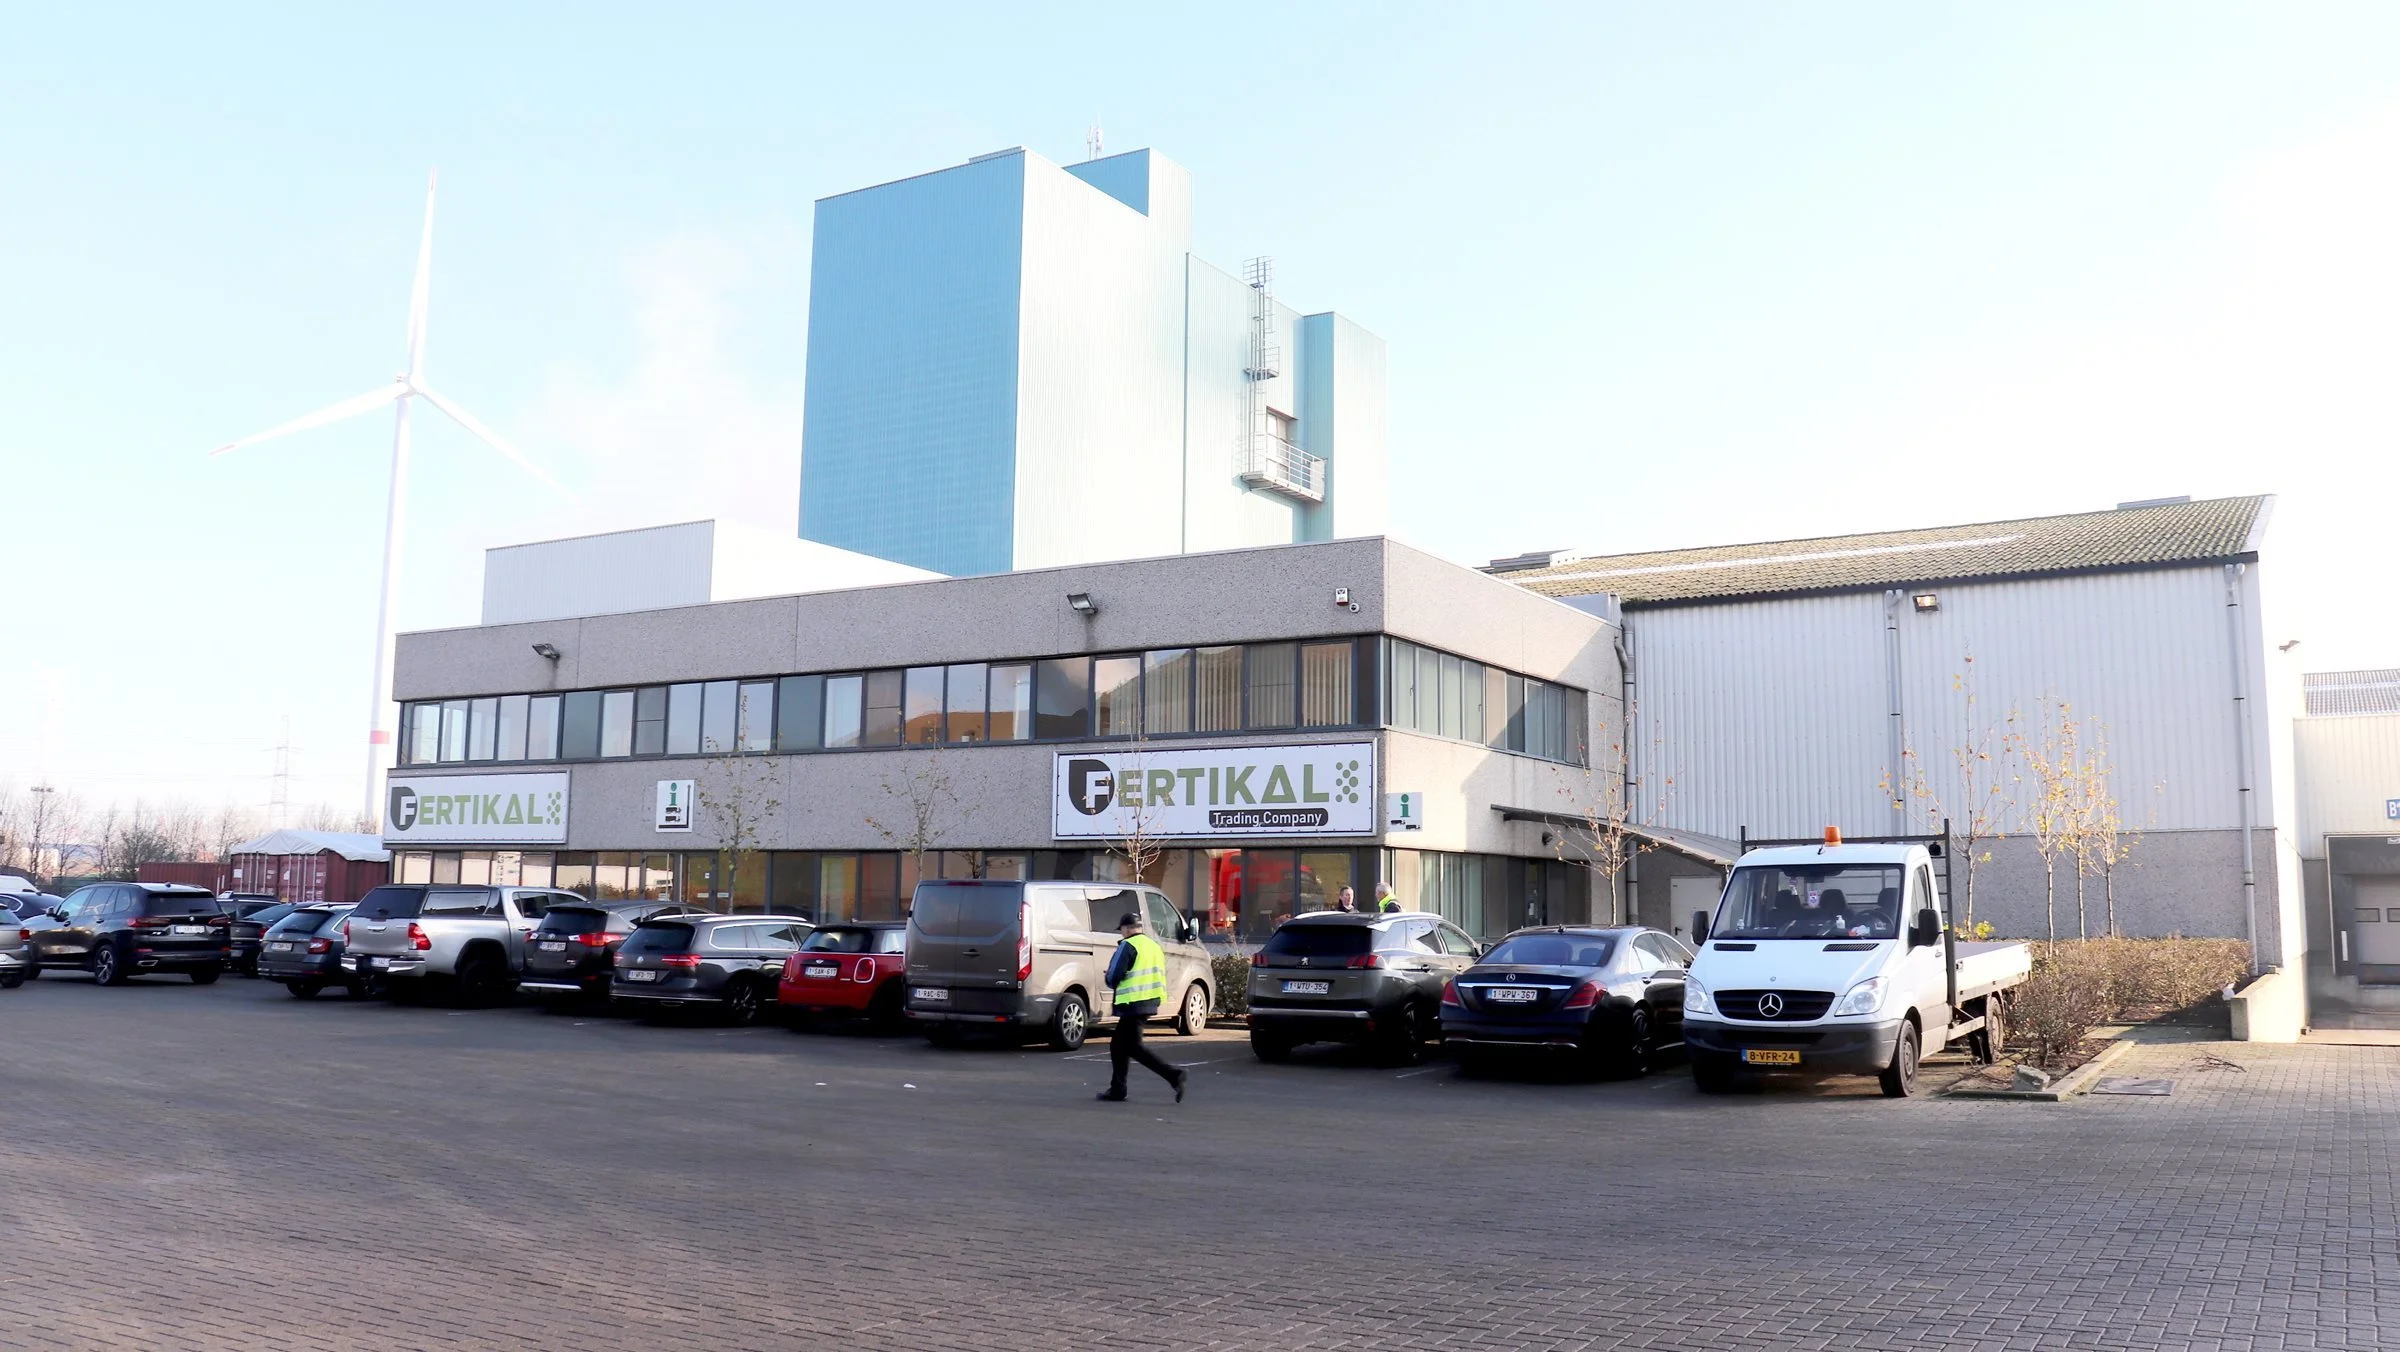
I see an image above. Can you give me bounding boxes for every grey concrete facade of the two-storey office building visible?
[394,538,1622,883]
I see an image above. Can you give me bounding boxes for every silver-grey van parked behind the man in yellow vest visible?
[905,879,1217,1052]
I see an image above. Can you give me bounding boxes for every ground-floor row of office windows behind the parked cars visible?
[394,848,1606,944]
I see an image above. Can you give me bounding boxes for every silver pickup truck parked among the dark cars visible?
[341,884,583,1004]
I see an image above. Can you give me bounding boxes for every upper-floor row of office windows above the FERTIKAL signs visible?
[401,639,1582,766]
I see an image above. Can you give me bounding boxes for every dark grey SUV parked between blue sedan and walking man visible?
[1250,910,1481,1061]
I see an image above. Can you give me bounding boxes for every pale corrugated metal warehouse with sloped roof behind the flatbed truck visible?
[1493,497,2306,965]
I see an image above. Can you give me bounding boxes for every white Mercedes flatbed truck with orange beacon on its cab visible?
[1682,828,2033,1097]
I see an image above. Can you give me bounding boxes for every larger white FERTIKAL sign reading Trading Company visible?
[1051,742,1378,840]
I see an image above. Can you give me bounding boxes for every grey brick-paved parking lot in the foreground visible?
[0,975,2400,1350]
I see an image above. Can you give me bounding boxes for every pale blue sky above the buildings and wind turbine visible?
[0,0,2400,807]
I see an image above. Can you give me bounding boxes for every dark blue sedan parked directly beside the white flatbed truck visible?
[1442,925,1692,1076]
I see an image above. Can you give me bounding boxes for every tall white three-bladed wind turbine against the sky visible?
[209,173,566,831]
